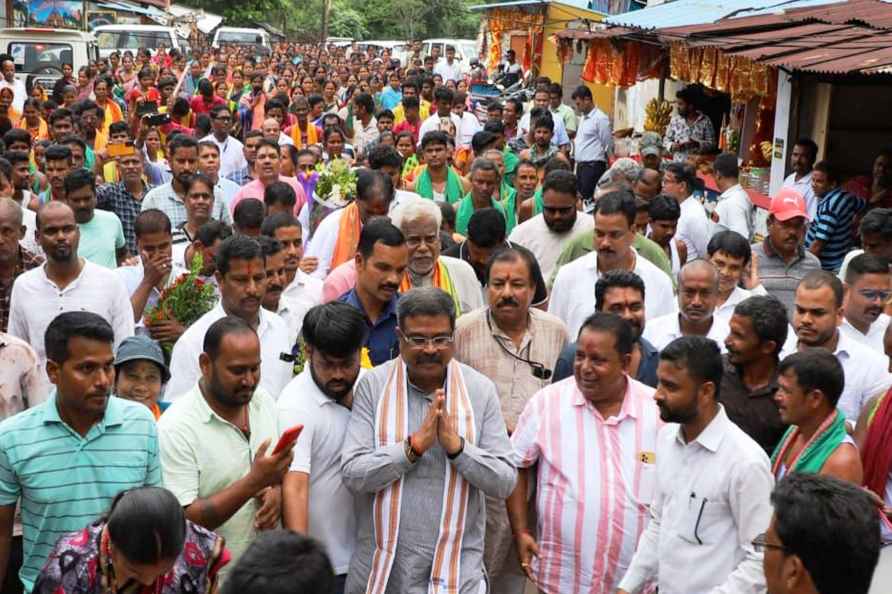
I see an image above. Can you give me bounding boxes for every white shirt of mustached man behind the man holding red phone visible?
[164,303,294,401]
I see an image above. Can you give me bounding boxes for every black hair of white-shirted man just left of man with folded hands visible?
[301,301,369,358]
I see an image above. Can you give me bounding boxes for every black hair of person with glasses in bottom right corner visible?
[771,472,881,594]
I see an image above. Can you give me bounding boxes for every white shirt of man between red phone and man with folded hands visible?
[276,363,356,575]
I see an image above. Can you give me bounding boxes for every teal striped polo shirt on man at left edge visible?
[0,392,161,592]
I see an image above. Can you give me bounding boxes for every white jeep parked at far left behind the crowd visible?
[0,28,99,89]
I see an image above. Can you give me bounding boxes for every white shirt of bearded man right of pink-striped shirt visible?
[619,404,774,594]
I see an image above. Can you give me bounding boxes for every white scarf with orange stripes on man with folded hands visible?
[366,357,476,594]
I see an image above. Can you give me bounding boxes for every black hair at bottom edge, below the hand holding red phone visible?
[220,530,335,594]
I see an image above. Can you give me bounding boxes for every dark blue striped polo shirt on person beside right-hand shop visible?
[805,188,864,272]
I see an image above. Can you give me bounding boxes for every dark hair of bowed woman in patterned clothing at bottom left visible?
[105,487,186,565]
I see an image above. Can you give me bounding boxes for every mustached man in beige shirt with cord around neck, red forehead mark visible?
[455,246,575,593]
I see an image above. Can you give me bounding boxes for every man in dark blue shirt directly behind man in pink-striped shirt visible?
[551,270,660,388]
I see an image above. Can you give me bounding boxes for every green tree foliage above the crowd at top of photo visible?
[184,0,480,40]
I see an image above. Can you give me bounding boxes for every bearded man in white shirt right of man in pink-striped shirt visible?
[617,336,774,594]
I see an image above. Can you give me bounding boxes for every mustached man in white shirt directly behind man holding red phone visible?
[165,235,292,401]
